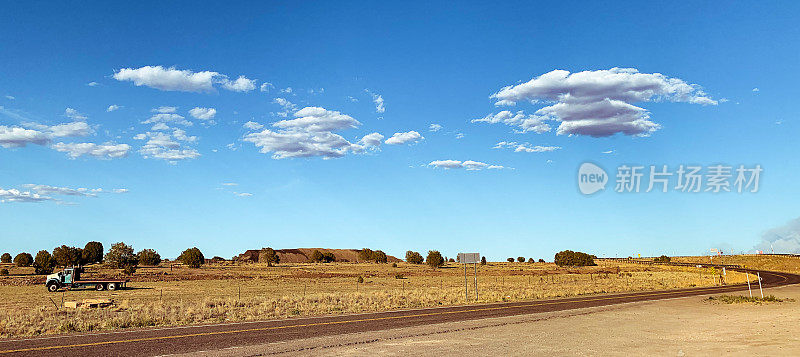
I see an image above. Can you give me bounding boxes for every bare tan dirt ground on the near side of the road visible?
[195,286,800,356]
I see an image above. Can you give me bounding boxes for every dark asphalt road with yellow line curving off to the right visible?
[0,270,800,356]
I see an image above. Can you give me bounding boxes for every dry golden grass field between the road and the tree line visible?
[0,262,745,337]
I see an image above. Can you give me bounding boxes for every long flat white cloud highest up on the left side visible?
[113,66,255,93]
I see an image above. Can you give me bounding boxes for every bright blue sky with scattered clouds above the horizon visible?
[0,2,800,259]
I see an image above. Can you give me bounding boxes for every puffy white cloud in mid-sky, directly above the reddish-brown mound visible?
[242,107,364,159]
